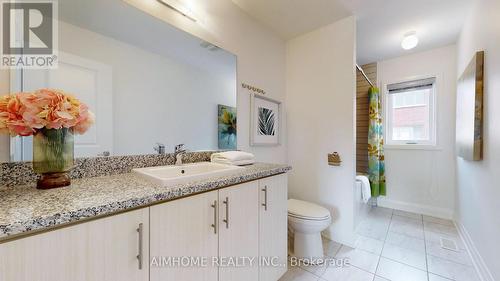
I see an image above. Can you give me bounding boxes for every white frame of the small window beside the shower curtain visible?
[382,75,441,149]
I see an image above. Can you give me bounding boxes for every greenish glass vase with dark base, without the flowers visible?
[33,128,74,189]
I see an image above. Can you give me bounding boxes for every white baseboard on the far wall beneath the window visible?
[378,196,454,220]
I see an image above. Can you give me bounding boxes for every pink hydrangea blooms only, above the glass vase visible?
[0,89,94,136]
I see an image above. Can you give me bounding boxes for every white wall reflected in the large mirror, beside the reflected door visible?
[59,22,236,155]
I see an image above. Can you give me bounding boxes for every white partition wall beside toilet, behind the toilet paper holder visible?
[286,17,356,245]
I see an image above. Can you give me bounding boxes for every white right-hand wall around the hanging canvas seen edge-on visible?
[456,0,500,281]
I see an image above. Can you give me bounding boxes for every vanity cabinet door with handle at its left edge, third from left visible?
[219,181,259,281]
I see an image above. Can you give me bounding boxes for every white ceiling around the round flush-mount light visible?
[232,0,475,64]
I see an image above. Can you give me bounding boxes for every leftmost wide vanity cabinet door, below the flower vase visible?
[0,208,149,281]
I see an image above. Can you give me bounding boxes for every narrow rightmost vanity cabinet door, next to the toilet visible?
[259,174,288,281]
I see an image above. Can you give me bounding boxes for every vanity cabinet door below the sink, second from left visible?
[150,191,219,281]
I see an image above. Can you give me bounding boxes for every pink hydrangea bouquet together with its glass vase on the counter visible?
[0,89,94,189]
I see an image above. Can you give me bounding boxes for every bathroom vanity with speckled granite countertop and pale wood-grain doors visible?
[0,163,289,281]
